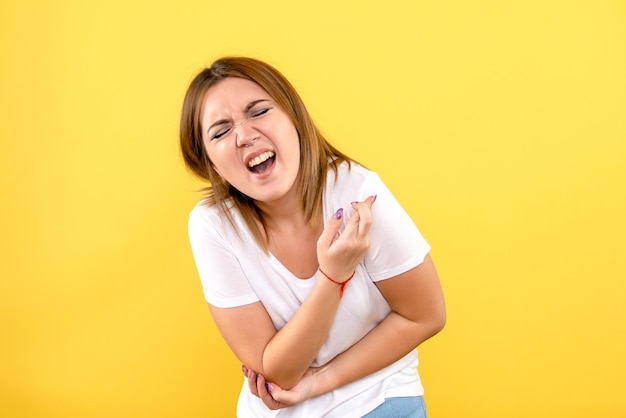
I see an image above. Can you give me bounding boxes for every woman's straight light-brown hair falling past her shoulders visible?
[180,57,354,251]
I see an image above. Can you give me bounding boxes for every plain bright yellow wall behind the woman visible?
[0,0,626,418]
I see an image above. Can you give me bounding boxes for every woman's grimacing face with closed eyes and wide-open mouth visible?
[201,77,300,203]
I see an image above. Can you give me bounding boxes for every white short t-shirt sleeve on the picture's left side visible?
[188,204,259,308]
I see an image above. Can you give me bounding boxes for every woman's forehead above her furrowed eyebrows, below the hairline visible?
[202,77,272,123]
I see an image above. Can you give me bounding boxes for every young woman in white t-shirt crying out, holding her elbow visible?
[180,57,445,418]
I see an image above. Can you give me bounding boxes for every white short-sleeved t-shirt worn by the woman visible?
[189,163,430,418]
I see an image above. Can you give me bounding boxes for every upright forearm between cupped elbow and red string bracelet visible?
[262,277,340,388]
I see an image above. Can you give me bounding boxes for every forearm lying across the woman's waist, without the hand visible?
[314,312,445,396]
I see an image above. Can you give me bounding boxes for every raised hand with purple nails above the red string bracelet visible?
[317,196,376,283]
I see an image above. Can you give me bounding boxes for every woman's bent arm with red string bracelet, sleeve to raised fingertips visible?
[200,197,374,388]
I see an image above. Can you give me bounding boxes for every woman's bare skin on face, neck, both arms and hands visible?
[201,78,445,409]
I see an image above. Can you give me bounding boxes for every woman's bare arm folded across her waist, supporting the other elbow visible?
[251,255,446,408]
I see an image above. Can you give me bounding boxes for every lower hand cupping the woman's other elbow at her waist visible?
[241,366,318,410]
